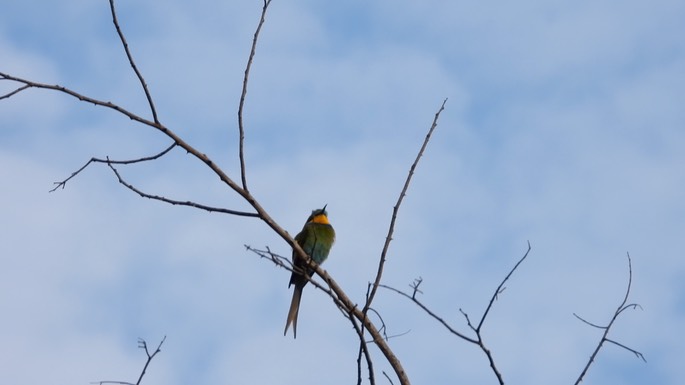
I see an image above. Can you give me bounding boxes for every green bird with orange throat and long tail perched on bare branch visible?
[283,205,335,338]
